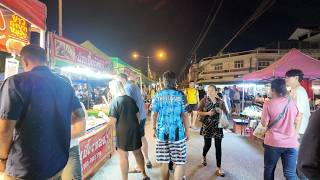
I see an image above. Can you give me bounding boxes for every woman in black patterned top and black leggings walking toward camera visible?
[198,85,227,177]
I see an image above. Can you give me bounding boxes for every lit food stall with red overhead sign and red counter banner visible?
[48,33,115,179]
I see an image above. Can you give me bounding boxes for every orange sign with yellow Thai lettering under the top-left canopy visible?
[0,6,31,55]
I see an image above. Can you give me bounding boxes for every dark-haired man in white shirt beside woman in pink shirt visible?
[286,69,311,140]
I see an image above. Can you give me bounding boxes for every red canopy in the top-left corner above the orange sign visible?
[0,0,47,30]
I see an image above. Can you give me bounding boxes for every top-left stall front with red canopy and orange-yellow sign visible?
[0,0,47,81]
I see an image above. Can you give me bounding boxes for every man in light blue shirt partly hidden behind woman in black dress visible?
[119,73,152,169]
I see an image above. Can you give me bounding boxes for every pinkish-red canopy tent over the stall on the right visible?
[243,49,320,81]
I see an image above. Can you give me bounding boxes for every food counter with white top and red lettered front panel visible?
[79,118,115,179]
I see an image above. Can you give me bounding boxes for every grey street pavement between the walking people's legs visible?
[92,121,285,180]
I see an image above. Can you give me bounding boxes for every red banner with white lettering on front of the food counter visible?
[80,124,114,178]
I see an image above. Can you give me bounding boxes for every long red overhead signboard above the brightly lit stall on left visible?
[50,34,112,71]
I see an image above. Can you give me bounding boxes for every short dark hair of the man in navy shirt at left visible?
[20,44,47,63]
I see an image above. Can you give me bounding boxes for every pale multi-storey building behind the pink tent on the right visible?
[188,28,320,84]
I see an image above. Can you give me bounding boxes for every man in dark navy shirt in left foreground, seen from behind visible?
[0,45,84,179]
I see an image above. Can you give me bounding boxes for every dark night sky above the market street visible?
[41,0,320,73]
